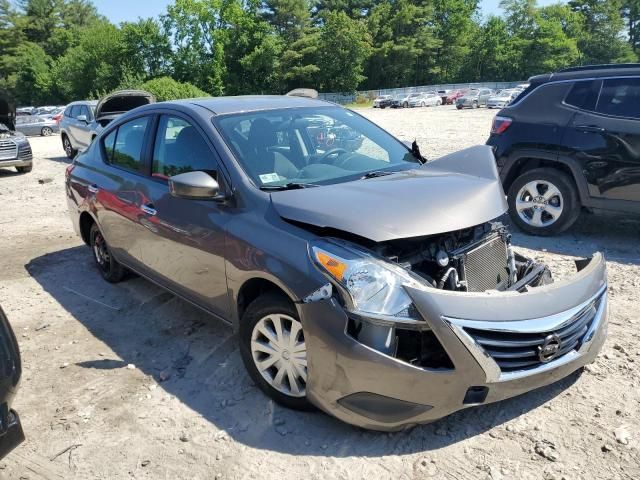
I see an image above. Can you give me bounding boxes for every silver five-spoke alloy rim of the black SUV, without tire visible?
[515,180,564,228]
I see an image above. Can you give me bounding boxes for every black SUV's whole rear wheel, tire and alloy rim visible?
[507,168,581,236]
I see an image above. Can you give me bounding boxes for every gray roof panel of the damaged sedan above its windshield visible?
[162,95,336,115]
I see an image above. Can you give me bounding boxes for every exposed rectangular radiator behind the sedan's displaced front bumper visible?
[462,236,509,292]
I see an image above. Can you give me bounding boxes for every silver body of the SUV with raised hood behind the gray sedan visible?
[60,100,98,158]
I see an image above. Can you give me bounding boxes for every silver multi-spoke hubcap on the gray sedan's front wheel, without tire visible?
[251,314,307,398]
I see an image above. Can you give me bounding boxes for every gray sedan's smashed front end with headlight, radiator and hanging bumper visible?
[304,222,607,430]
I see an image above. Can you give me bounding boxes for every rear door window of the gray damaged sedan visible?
[103,117,149,172]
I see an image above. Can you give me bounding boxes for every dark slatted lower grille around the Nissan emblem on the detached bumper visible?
[464,297,602,372]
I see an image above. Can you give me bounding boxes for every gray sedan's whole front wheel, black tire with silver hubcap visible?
[239,293,314,410]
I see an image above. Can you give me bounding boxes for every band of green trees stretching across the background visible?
[0,0,640,104]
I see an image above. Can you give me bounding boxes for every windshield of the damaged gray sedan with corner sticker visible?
[213,107,421,187]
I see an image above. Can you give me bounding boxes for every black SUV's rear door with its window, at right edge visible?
[563,78,640,201]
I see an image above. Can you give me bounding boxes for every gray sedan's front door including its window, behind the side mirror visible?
[138,113,230,317]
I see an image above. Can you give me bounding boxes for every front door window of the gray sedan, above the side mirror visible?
[151,115,218,180]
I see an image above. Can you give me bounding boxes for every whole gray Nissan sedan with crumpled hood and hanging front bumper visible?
[66,96,607,430]
